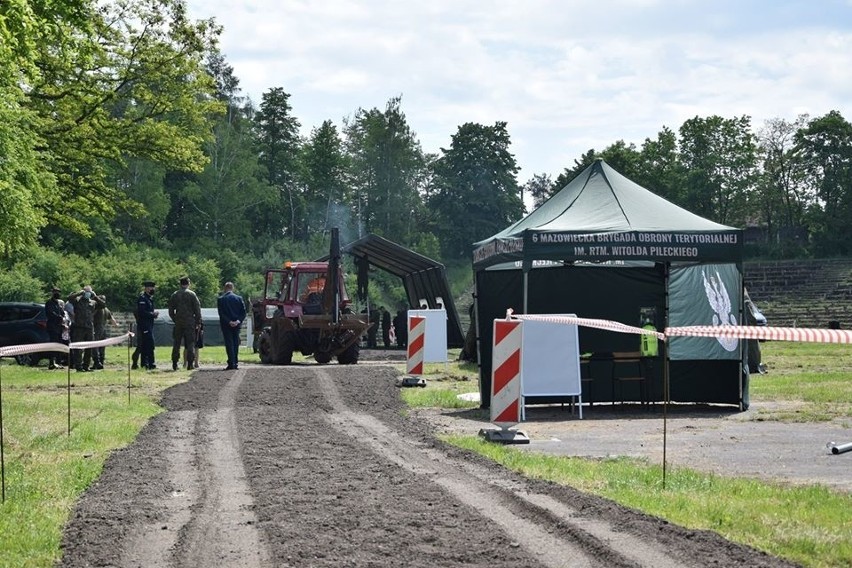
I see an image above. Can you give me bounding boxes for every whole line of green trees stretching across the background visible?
[0,0,852,308]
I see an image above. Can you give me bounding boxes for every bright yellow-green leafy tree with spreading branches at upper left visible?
[25,0,219,240]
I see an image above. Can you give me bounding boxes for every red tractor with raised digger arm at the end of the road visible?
[252,229,370,365]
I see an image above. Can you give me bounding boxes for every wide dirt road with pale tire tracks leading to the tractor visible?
[56,365,790,568]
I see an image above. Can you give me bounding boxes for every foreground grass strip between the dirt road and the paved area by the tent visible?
[447,436,852,567]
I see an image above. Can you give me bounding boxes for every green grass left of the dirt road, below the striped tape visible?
[0,346,206,568]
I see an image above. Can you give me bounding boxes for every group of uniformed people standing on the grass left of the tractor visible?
[44,276,246,372]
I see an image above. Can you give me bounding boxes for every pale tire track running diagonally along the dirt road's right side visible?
[316,369,684,568]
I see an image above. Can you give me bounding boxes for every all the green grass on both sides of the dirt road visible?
[0,343,852,568]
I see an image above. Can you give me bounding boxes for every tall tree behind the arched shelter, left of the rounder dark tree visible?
[344,97,426,243]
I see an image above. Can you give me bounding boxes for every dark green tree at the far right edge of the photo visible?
[796,110,852,254]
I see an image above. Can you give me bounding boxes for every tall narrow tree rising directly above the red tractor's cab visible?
[253,87,308,241]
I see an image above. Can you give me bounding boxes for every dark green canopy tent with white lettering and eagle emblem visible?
[473,160,748,408]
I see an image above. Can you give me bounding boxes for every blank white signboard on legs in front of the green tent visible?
[521,314,583,418]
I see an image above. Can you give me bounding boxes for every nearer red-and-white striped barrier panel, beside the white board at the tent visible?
[491,320,523,429]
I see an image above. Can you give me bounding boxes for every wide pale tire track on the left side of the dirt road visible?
[119,371,269,568]
